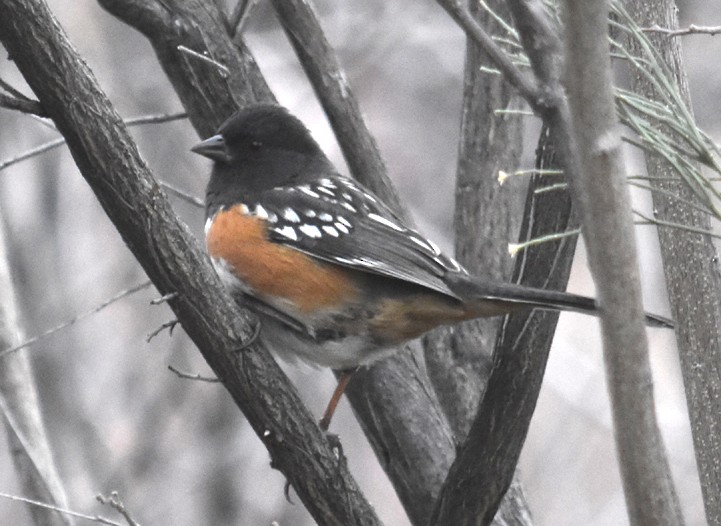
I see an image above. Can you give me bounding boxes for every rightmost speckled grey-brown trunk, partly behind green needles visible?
[624,0,721,525]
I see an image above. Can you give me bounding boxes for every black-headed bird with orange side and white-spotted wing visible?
[191,104,673,431]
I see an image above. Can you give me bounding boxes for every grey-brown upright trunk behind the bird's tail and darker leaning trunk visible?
[423,1,531,524]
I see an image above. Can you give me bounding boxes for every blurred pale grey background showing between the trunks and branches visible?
[0,0,721,526]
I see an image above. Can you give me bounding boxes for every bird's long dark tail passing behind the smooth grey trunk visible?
[449,276,674,329]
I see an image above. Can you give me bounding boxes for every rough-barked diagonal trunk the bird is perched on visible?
[0,0,379,524]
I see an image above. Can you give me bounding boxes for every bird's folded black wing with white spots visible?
[249,176,465,298]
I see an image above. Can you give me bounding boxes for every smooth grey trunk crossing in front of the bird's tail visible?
[564,0,683,525]
